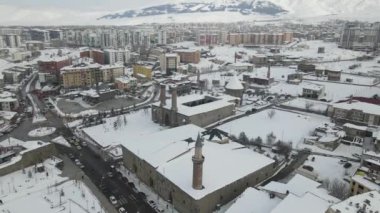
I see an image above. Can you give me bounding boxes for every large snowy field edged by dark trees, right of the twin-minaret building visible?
[218,109,329,146]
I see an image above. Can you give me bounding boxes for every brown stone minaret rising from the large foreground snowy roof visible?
[192,134,205,190]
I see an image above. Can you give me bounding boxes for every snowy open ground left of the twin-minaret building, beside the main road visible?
[83,110,163,147]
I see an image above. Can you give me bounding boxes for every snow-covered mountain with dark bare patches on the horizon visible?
[99,0,380,22]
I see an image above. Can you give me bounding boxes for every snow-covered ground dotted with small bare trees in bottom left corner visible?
[0,159,102,213]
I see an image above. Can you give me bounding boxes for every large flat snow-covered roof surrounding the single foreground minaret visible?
[123,124,274,199]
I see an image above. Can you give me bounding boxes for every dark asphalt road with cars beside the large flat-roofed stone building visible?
[59,141,155,213]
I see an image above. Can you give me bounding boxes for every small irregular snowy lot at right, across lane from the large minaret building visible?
[304,155,359,181]
